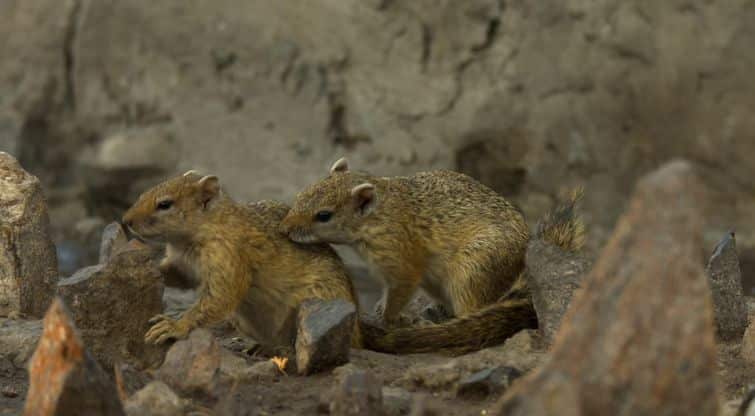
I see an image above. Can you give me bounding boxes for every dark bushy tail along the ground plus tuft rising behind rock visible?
[360,188,585,355]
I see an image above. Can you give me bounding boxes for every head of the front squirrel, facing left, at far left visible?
[122,170,221,243]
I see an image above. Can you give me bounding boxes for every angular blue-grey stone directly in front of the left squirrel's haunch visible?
[296,299,356,375]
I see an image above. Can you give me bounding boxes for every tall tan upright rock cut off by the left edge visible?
[0,152,58,317]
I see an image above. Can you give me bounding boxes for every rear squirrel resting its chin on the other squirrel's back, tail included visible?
[281,158,585,353]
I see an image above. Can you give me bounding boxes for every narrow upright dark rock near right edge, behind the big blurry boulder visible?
[706,233,748,340]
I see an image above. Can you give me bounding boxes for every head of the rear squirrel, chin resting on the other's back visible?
[280,158,378,244]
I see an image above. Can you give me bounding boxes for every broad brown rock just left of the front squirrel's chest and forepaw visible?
[58,247,165,368]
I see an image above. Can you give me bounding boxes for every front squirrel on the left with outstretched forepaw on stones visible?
[122,171,362,349]
